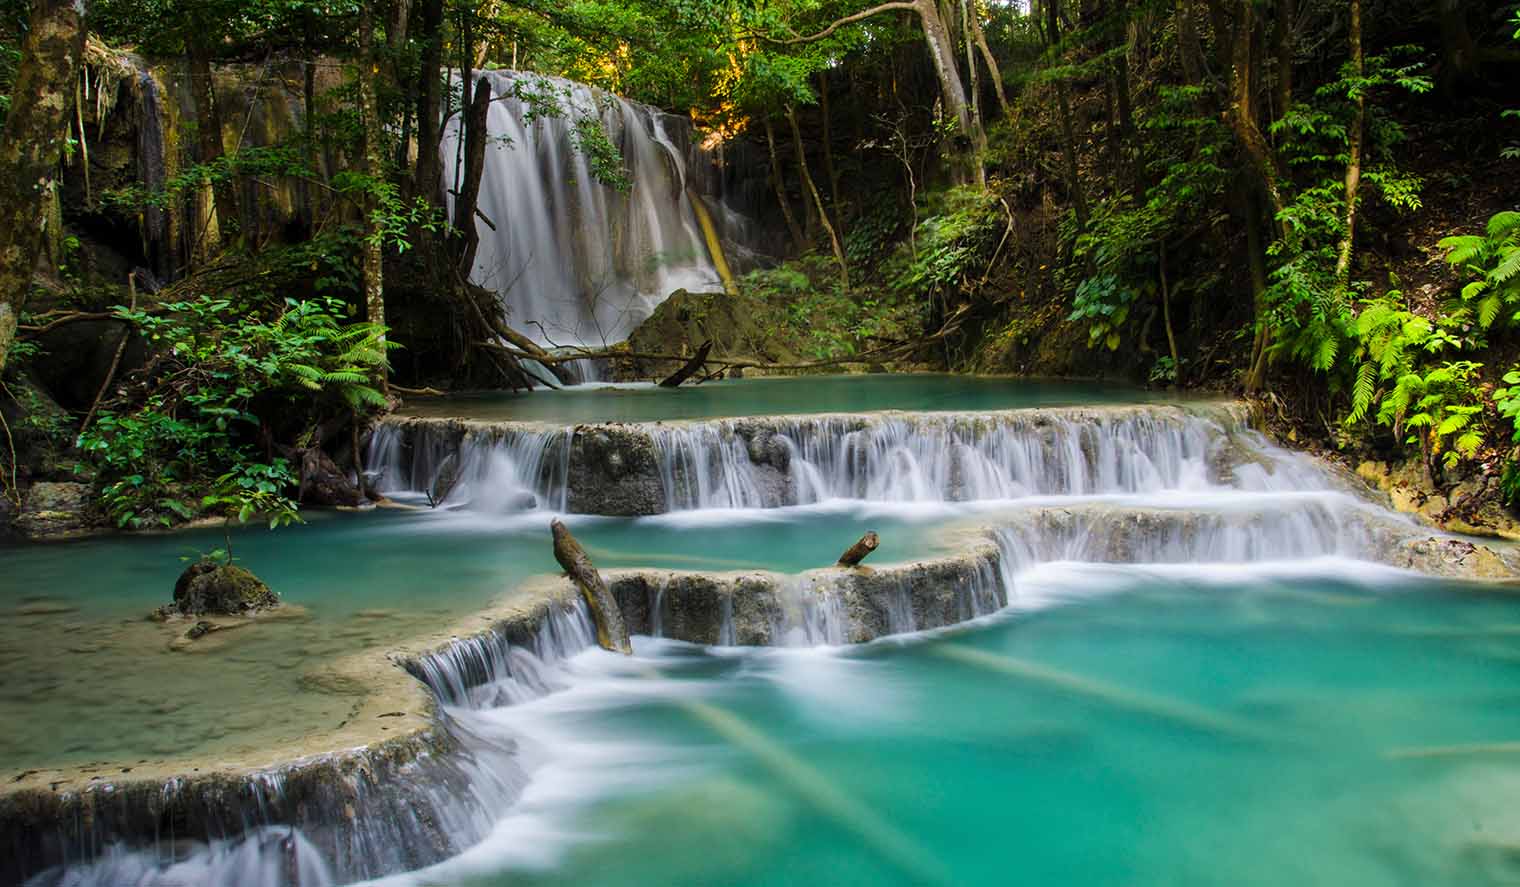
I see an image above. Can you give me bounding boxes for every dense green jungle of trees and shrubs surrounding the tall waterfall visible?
[0,0,1520,527]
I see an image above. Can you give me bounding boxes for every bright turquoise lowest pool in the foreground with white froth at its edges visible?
[395,563,1520,887]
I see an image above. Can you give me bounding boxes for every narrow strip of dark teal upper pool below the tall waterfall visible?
[401,374,1163,424]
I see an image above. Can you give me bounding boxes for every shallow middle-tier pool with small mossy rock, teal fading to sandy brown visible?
[0,509,935,773]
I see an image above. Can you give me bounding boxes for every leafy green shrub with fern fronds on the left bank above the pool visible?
[78,298,388,527]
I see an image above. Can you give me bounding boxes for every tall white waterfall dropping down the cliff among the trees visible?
[441,71,736,346]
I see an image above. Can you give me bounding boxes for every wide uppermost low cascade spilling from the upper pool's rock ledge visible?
[368,407,1307,515]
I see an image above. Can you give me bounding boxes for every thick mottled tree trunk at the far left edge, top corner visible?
[0,0,85,371]
